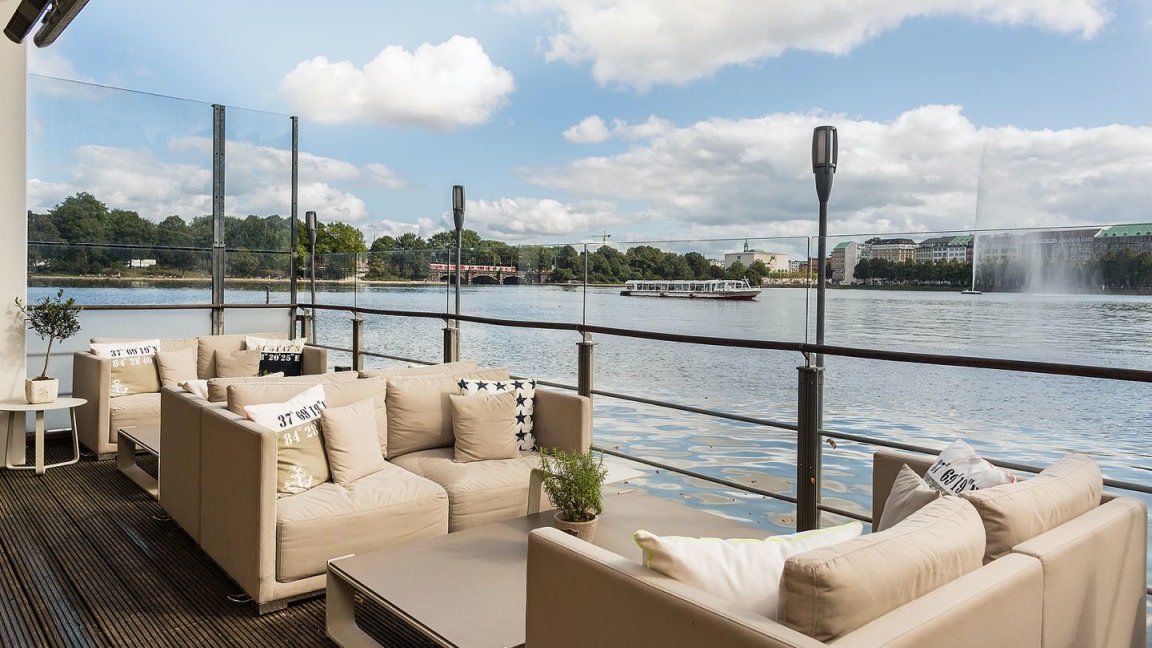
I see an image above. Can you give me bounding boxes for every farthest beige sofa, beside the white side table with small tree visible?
[73,333,328,459]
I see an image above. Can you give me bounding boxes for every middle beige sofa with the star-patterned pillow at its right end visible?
[160,362,591,613]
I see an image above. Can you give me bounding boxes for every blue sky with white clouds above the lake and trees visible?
[18,0,1152,253]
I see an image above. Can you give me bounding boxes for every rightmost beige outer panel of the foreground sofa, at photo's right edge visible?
[1013,497,1147,648]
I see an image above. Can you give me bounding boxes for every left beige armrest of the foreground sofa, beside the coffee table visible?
[524,527,824,648]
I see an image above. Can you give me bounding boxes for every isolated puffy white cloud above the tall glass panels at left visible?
[280,36,516,130]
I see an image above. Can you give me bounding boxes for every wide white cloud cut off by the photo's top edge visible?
[517,0,1112,91]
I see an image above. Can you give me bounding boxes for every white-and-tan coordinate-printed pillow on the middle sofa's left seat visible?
[244,385,331,497]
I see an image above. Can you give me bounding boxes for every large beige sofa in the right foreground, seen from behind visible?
[526,452,1147,648]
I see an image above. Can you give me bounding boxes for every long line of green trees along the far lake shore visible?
[28,193,768,284]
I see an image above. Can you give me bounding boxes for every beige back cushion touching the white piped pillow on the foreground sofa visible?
[779,497,984,641]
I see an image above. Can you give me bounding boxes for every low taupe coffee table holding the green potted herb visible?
[327,490,772,647]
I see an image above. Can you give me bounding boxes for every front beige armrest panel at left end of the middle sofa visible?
[200,409,278,601]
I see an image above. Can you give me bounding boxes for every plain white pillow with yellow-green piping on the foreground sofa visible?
[634,522,864,620]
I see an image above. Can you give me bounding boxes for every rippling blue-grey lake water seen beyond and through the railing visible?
[38,285,1152,530]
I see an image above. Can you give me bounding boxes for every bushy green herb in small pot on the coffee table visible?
[539,449,607,540]
